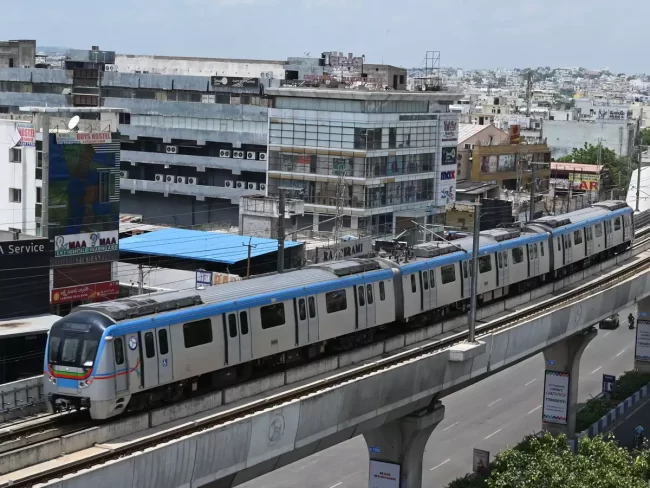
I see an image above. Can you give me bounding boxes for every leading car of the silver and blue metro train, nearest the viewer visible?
[45,260,396,419]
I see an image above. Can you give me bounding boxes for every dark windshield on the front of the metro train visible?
[49,322,101,368]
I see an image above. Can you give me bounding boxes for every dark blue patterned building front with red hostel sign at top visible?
[46,133,120,238]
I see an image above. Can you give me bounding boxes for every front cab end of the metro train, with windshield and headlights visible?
[43,310,115,418]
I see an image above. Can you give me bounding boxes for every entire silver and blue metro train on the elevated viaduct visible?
[44,201,634,419]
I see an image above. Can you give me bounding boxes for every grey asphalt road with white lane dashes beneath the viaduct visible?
[240,310,632,488]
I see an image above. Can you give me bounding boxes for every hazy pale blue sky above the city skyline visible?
[5,0,650,73]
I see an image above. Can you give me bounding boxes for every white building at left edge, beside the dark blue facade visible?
[0,116,42,235]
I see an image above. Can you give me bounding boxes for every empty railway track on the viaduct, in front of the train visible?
[11,235,650,488]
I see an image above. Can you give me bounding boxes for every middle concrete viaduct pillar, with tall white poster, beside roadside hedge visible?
[542,329,598,439]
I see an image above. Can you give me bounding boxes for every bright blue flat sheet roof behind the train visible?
[120,228,302,264]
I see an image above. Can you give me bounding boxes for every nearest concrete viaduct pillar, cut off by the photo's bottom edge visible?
[363,401,445,488]
